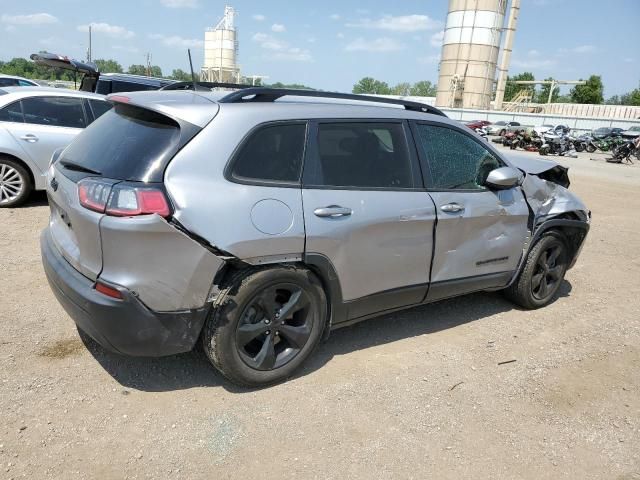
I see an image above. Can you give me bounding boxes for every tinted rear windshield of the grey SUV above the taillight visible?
[60,104,195,182]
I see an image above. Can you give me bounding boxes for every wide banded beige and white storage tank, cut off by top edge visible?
[436,0,507,109]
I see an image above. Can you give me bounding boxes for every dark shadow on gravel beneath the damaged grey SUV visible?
[80,280,571,393]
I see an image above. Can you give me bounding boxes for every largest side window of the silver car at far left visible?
[22,97,86,128]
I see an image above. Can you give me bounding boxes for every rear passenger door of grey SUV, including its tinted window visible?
[302,120,435,318]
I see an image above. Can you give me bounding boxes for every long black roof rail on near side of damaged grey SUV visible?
[218,87,446,117]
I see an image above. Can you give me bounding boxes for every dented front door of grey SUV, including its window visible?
[414,122,529,300]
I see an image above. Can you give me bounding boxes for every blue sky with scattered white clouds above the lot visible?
[0,0,640,98]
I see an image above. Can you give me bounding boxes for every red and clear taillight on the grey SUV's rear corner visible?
[78,178,171,217]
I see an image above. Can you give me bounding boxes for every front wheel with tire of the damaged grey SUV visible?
[505,232,568,310]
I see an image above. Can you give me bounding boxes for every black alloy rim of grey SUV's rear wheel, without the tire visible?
[236,283,312,370]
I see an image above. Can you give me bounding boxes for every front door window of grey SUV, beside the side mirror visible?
[416,124,504,190]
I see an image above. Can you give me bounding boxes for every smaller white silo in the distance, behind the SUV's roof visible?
[200,6,240,83]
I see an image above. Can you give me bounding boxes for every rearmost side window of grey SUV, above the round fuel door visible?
[231,123,307,182]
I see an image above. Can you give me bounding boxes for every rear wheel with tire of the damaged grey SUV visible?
[202,266,327,387]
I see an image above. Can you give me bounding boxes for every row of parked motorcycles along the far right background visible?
[476,129,640,163]
